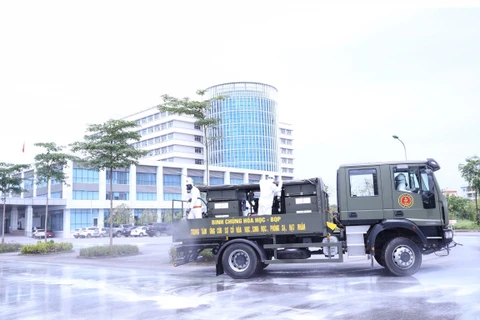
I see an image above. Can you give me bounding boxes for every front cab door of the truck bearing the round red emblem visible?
[386,165,442,226]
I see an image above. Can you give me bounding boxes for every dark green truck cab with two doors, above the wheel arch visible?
[337,159,449,227]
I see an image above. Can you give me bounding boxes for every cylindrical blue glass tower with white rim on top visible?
[207,82,279,172]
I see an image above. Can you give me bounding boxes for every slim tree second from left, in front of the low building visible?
[34,142,76,242]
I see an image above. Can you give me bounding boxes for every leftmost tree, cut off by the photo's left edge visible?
[0,162,30,244]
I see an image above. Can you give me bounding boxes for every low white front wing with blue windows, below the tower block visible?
[2,160,292,238]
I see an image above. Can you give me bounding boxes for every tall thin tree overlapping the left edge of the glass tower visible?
[157,90,226,185]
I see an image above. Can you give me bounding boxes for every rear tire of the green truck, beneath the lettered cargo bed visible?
[222,243,259,279]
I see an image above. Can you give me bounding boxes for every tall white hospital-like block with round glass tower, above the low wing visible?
[124,82,294,180]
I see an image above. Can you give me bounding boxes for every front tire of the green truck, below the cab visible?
[382,237,422,277]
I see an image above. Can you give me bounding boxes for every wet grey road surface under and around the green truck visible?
[0,233,480,320]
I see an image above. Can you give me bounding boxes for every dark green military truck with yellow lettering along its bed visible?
[173,159,455,279]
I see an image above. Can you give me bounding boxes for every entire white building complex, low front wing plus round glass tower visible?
[1,82,294,238]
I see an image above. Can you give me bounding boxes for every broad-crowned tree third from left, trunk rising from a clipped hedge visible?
[71,119,147,245]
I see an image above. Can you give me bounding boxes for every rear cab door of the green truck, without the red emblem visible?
[340,166,384,225]
